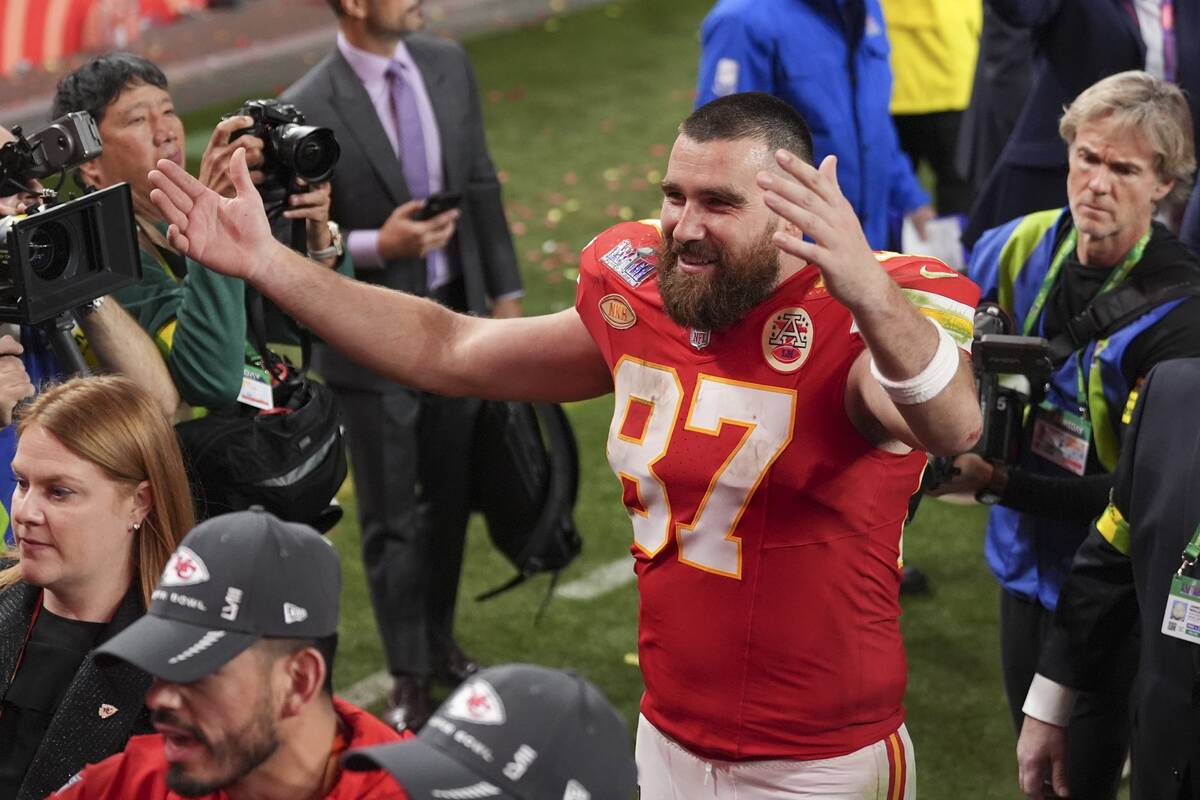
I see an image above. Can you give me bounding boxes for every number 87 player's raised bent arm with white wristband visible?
[758,150,982,455]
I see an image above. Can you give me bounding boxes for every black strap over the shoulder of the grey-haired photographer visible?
[1050,263,1200,369]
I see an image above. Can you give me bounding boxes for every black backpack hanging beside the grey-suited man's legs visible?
[472,401,582,616]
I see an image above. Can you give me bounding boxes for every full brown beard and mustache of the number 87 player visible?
[658,219,779,331]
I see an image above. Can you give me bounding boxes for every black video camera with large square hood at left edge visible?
[0,112,142,325]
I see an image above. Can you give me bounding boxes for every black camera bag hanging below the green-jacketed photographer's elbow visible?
[175,287,347,531]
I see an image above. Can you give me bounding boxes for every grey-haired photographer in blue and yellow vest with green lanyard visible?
[938,72,1200,798]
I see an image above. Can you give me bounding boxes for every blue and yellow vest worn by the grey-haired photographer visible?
[967,209,1184,610]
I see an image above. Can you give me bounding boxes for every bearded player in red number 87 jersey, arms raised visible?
[140,92,980,800]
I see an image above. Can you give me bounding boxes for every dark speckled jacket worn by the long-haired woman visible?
[0,582,152,800]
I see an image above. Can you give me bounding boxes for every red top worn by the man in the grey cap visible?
[50,697,412,800]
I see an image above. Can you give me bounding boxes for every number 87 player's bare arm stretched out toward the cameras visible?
[150,151,612,401]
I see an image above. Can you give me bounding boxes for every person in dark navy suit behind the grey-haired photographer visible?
[962,0,1200,246]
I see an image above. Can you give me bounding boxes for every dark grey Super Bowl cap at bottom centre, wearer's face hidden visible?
[344,664,637,800]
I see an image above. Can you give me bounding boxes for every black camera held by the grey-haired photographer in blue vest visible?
[922,302,1054,489]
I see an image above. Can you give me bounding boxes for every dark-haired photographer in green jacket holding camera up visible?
[53,53,336,408]
